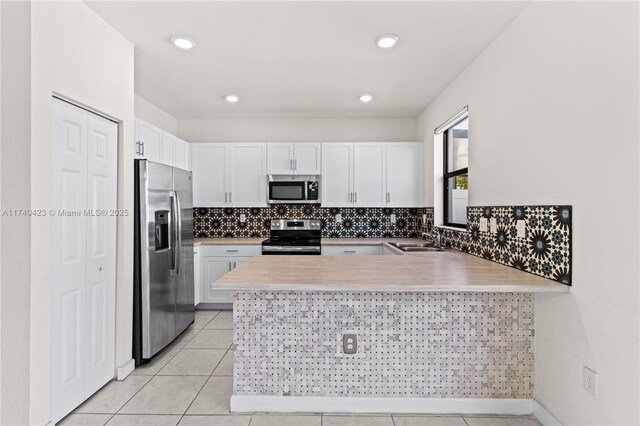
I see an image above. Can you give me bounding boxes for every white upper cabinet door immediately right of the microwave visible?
[320,143,353,207]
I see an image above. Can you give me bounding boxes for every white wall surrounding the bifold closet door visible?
[29,2,134,424]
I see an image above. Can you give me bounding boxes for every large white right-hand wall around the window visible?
[418,2,640,425]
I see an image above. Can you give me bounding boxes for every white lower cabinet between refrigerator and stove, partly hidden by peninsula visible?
[199,245,262,303]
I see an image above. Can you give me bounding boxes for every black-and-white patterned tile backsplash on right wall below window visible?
[424,205,572,285]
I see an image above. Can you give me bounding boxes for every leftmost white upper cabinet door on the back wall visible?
[192,143,229,207]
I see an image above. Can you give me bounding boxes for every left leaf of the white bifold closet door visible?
[51,101,88,421]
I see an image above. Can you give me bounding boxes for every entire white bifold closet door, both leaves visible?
[51,100,117,422]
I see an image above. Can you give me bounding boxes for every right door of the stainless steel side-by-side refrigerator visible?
[173,169,195,335]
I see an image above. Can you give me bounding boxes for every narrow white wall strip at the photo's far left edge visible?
[0,2,32,424]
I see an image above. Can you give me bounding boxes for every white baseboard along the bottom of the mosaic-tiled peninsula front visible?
[231,395,533,415]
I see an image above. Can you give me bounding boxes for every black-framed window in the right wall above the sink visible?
[443,117,469,228]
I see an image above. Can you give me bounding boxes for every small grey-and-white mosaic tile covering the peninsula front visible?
[233,292,534,399]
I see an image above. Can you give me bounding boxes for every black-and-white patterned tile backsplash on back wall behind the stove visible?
[193,204,433,238]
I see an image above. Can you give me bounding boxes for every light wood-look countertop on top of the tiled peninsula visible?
[211,251,569,293]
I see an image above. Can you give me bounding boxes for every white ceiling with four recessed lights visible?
[87,1,526,119]
